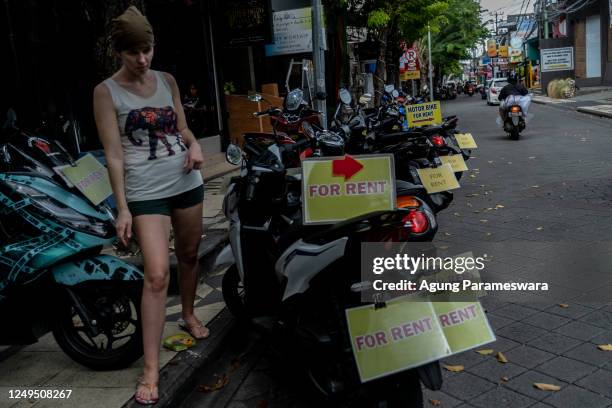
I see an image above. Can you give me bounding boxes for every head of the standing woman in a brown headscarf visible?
[111,6,154,74]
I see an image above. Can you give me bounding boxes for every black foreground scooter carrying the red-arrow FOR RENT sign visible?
[216,130,442,407]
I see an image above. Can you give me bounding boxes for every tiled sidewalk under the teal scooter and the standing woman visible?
[0,159,236,408]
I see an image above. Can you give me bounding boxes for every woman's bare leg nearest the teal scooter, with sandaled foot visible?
[134,215,170,399]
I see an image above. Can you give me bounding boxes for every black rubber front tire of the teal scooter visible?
[52,283,143,371]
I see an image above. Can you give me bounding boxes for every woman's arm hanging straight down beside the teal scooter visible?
[93,84,132,245]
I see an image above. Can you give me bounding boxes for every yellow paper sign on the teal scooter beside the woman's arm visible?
[61,154,113,205]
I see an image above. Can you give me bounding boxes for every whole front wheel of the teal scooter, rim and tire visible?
[53,281,143,370]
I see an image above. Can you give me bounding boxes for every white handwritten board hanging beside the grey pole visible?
[266,7,326,57]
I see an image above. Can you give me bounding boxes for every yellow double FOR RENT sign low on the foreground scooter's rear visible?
[346,294,495,382]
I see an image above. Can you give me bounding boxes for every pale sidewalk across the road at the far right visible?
[533,87,612,118]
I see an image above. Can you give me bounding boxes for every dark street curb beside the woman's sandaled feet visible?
[122,309,235,408]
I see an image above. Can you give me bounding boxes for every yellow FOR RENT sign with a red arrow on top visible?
[302,154,395,224]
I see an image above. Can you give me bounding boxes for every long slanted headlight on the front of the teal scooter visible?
[5,180,112,238]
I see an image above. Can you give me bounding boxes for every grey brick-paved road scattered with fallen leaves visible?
[183,96,612,408]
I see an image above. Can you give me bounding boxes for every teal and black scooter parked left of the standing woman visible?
[0,112,143,370]
